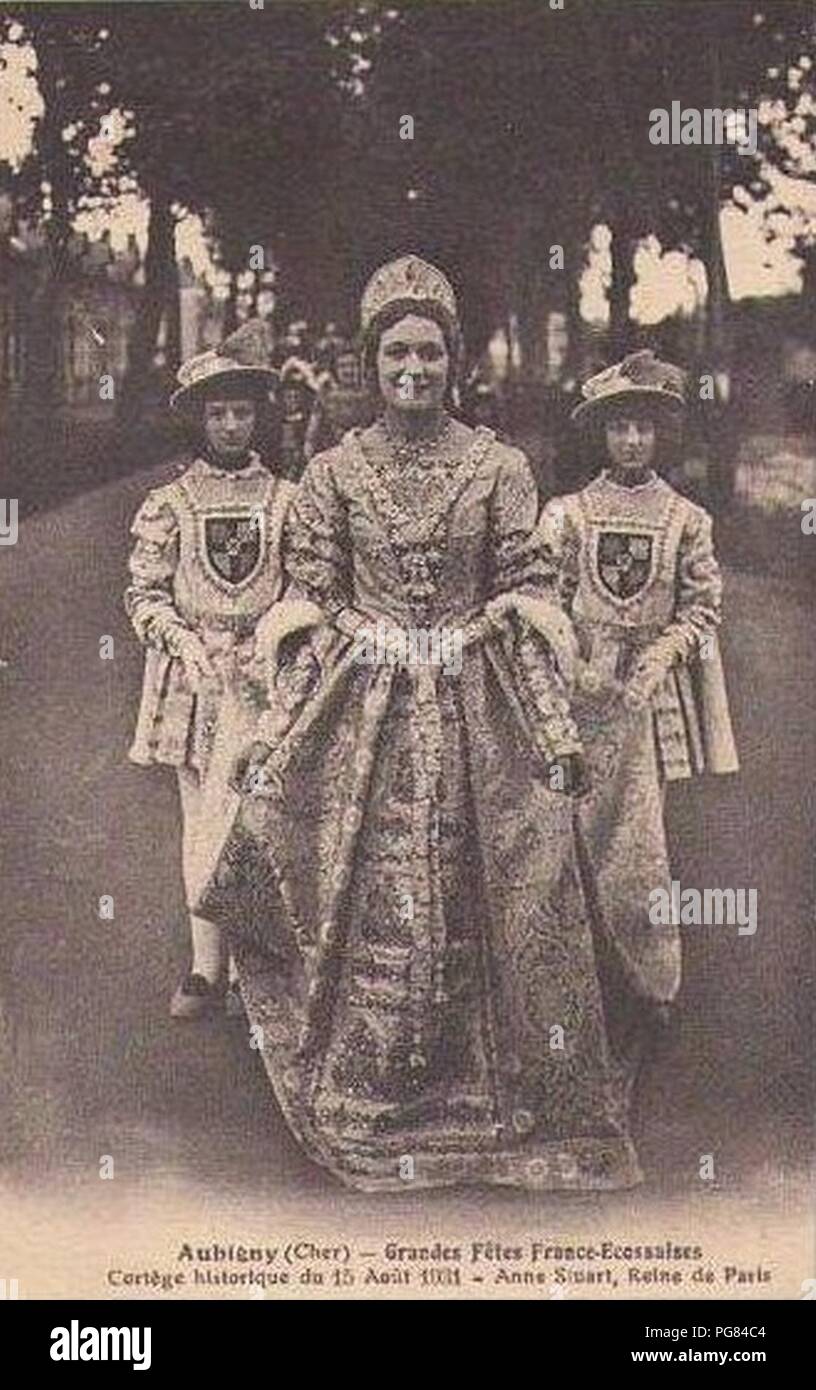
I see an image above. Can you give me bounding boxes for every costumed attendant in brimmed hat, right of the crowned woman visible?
[541,350,738,1061]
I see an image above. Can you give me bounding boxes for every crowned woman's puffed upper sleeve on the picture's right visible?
[491,446,557,596]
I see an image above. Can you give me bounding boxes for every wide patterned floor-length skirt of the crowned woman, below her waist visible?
[196,644,658,1190]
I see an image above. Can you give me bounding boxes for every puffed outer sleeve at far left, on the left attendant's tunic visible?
[125,489,188,653]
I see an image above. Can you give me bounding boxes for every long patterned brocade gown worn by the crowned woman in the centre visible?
[197,421,659,1190]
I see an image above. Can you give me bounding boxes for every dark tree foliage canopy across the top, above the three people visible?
[6,0,816,411]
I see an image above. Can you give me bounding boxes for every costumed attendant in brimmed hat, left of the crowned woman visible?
[125,329,295,1017]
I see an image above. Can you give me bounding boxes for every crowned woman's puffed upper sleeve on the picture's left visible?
[284,449,352,617]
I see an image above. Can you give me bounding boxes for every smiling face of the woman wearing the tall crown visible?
[377,314,450,414]
